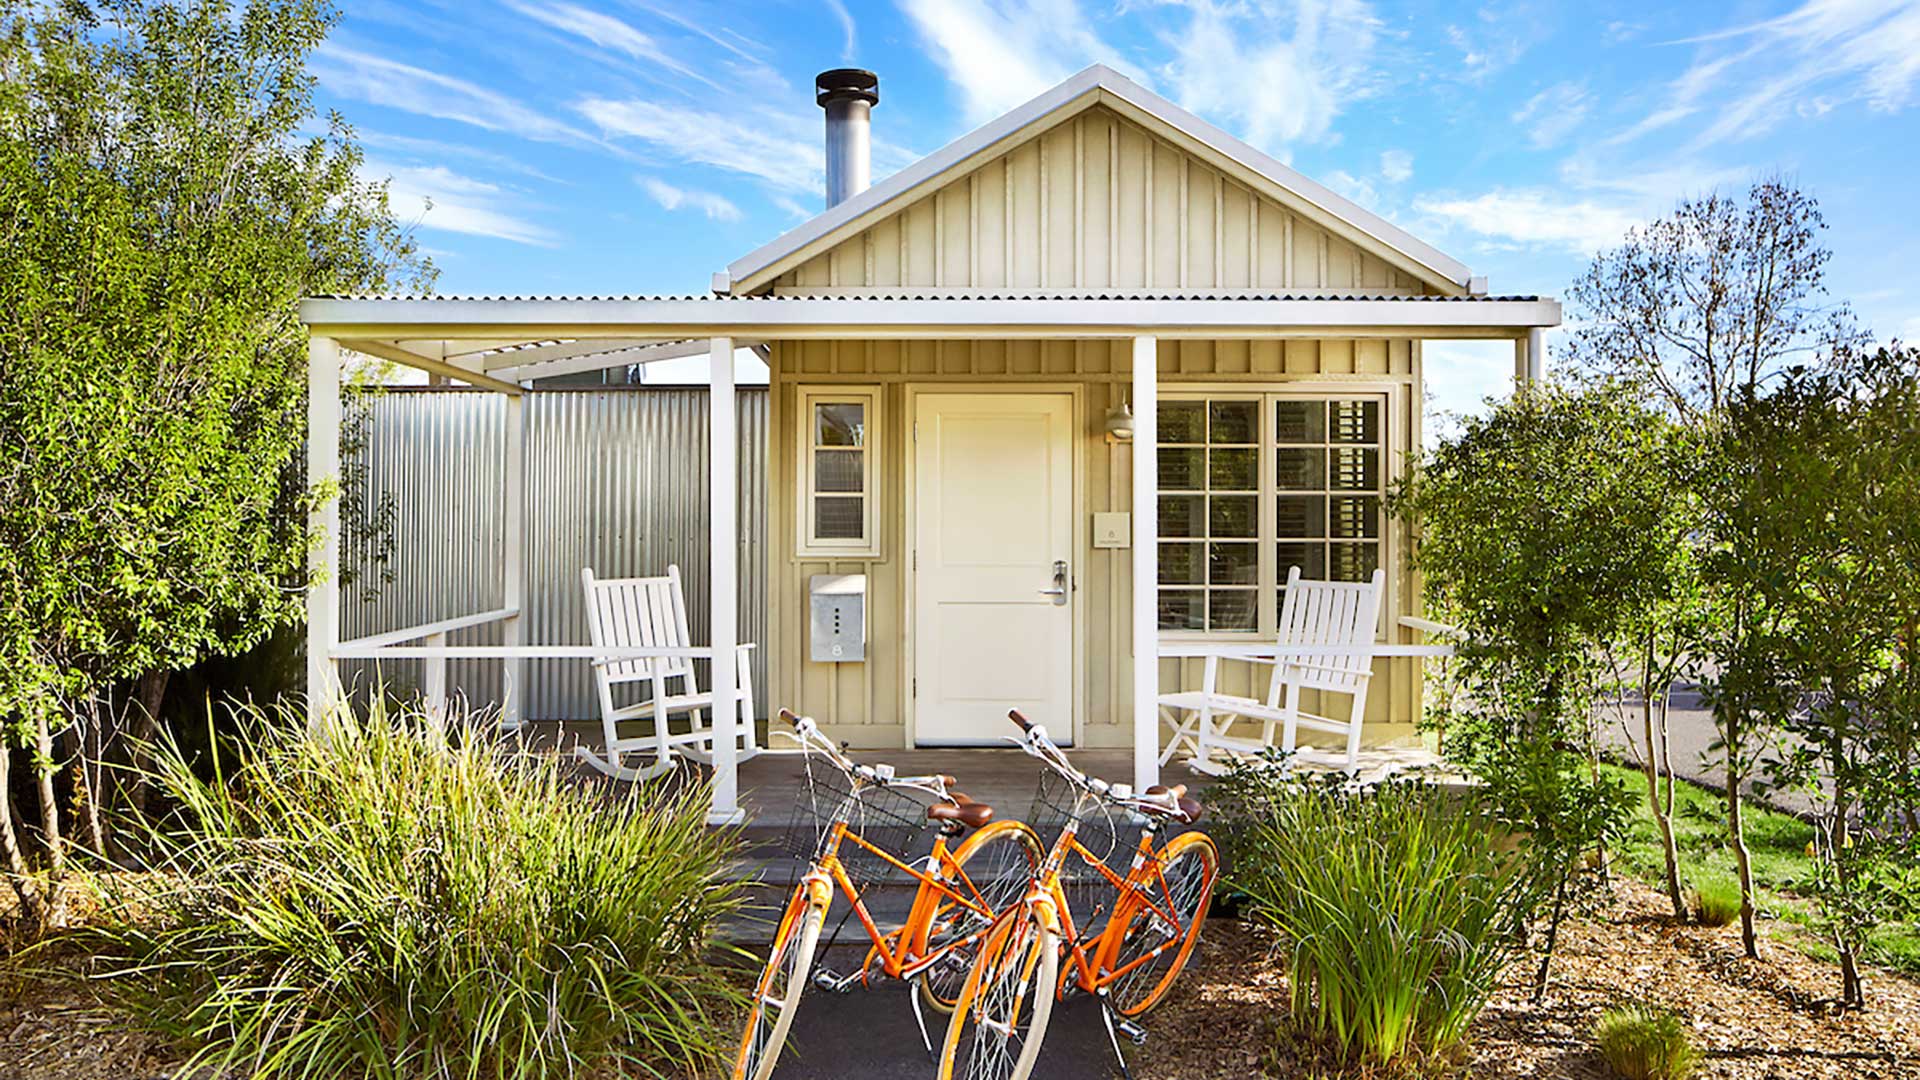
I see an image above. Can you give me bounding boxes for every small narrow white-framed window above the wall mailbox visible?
[799,386,879,555]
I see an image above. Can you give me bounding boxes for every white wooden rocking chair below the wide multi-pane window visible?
[1160,567,1386,773]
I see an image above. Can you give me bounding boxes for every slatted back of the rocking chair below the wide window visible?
[1267,567,1386,691]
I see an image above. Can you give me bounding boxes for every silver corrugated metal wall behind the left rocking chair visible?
[342,386,766,719]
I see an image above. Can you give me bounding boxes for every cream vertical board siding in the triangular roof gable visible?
[776,108,1423,294]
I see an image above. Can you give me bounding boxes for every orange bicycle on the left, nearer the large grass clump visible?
[733,709,1041,1080]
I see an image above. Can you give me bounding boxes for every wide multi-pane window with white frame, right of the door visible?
[1158,392,1386,634]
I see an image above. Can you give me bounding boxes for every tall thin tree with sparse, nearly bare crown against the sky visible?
[1567,179,1864,955]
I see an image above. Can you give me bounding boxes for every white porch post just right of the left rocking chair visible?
[707,338,745,824]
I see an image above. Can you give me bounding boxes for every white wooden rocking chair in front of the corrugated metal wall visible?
[574,565,760,780]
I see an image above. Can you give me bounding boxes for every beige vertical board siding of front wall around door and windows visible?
[766,338,1421,748]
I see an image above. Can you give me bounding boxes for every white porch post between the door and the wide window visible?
[1133,336,1160,792]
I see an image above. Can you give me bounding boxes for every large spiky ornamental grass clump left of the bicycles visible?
[80,705,737,1080]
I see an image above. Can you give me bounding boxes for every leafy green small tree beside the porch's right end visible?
[1392,384,1684,992]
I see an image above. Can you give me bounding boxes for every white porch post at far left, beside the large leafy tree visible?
[307,338,340,732]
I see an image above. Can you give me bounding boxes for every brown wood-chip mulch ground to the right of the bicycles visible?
[1133,882,1920,1080]
